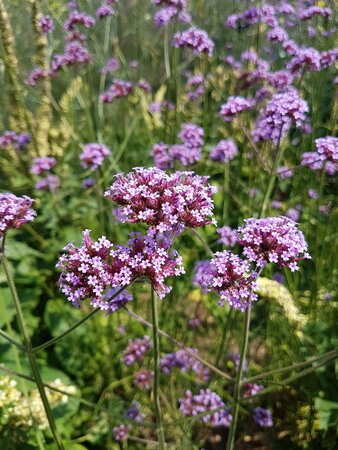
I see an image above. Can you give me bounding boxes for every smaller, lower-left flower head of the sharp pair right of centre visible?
[202,250,258,311]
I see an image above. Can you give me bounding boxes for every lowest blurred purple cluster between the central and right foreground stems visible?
[179,389,232,427]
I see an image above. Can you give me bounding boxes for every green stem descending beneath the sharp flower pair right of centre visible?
[226,304,251,450]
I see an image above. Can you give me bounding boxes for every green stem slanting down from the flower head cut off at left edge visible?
[0,249,64,450]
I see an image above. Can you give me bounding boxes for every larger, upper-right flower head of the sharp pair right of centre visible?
[238,216,310,272]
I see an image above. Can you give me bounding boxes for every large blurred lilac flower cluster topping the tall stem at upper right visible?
[252,88,309,145]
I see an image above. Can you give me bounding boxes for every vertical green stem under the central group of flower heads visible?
[151,289,165,450]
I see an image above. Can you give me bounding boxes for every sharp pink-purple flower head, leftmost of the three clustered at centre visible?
[56,230,112,310]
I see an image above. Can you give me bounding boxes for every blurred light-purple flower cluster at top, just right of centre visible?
[173,27,215,57]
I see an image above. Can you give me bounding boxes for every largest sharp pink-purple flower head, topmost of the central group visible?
[105,167,216,232]
